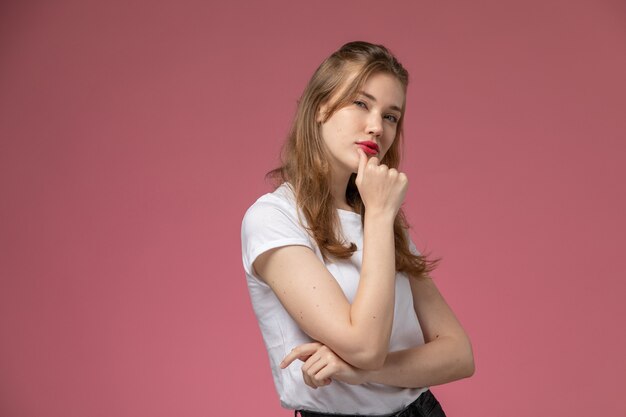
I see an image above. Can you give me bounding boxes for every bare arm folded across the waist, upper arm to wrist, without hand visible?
[362,277,474,388]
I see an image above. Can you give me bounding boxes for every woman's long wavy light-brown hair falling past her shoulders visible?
[267,41,439,278]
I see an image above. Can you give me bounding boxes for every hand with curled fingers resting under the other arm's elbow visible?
[280,342,366,389]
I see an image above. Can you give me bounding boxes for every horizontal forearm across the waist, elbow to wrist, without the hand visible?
[362,337,474,388]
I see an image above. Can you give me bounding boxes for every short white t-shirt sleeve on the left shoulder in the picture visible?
[241,198,314,279]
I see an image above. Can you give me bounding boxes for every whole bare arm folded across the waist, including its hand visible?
[282,278,474,388]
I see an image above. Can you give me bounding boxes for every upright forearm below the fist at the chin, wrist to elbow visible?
[350,213,396,368]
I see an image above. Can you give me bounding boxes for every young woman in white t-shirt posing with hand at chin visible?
[242,42,474,417]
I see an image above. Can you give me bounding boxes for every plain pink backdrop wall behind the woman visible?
[0,0,626,417]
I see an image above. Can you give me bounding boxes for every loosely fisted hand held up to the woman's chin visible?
[355,149,409,218]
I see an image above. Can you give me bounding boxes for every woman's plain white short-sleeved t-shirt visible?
[241,183,427,415]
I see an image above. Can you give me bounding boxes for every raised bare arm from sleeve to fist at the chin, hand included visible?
[254,150,407,369]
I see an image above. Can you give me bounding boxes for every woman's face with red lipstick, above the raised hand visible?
[320,73,404,176]
